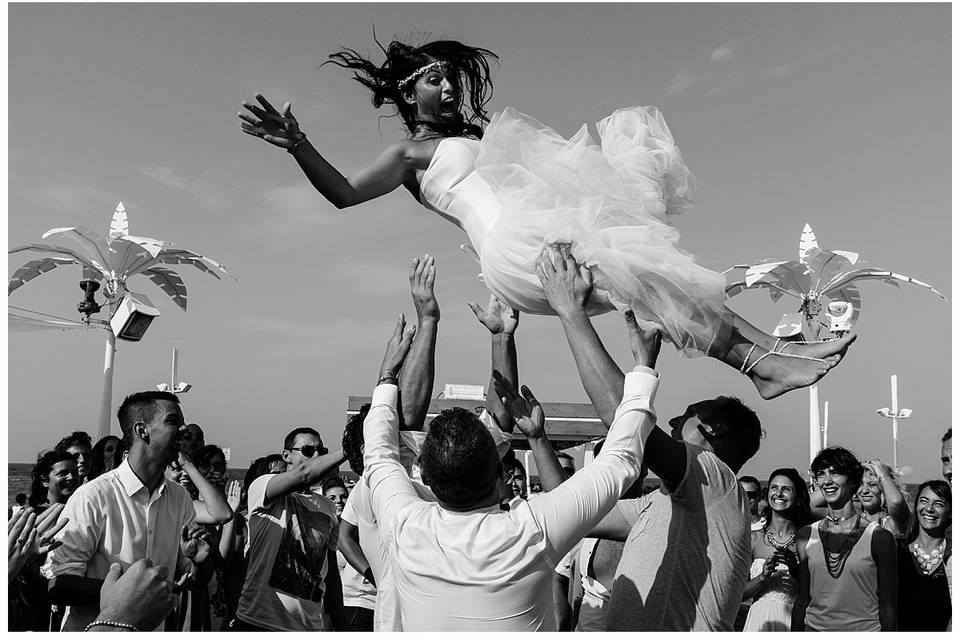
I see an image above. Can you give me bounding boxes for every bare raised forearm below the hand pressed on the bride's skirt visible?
[559,309,624,429]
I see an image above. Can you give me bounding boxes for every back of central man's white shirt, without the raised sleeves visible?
[387,496,569,631]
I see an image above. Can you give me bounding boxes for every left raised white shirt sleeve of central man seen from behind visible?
[363,384,420,539]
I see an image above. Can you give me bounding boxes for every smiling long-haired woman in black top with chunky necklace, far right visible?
[897,480,953,631]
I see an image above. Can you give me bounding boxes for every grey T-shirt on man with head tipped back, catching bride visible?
[607,443,750,631]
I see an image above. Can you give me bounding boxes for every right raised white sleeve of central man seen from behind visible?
[529,366,659,564]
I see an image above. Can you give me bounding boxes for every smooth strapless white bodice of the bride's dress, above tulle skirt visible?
[420,138,500,253]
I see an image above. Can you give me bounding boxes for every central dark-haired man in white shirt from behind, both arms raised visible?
[364,262,660,631]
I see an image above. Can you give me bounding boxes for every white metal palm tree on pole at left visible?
[7,202,236,436]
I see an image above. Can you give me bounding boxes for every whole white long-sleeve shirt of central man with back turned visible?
[363,367,658,631]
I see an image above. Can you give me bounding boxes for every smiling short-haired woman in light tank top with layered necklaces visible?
[792,447,897,631]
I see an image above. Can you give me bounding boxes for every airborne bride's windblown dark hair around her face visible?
[321,36,497,138]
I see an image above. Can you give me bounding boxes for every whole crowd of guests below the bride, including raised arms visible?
[8,251,952,631]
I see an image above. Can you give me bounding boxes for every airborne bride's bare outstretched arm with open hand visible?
[237,93,414,209]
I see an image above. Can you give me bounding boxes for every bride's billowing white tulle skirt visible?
[476,107,725,355]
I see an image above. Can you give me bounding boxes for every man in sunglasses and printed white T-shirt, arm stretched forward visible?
[235,427,345,631]
